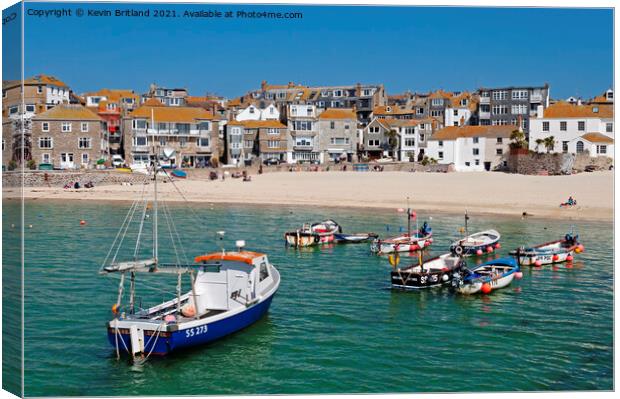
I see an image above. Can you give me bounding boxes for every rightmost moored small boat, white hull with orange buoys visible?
[510,233,584,266]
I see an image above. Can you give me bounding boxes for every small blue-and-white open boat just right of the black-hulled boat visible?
[454,257,521,295]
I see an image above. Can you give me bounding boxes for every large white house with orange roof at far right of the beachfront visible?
[529,101,614,158]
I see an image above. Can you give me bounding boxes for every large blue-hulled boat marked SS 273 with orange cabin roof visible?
[100,153,280,361]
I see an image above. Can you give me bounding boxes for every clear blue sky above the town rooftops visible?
[20,3,613,98]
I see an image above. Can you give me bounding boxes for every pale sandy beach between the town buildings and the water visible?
[4,171,613,221]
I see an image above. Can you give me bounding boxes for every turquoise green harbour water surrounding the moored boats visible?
[3,201,613,396]
